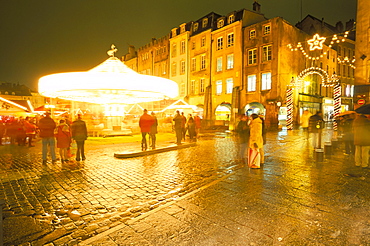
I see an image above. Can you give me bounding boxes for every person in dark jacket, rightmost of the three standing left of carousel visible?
[71,114,87,161]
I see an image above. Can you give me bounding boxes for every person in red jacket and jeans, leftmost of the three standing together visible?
[39,112,56,164]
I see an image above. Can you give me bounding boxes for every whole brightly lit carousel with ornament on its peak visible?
[39,45,178,131]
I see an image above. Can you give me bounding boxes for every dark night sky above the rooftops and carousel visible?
[0,0,357,90]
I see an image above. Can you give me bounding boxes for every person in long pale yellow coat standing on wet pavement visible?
[249,114,265,168]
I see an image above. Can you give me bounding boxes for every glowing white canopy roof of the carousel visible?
[39,49,178,104]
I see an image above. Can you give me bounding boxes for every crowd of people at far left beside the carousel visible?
[0,112,87,164]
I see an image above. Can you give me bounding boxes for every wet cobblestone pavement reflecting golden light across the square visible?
[0,131,370,246]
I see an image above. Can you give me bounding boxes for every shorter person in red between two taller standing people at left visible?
[55,120,71,163]
